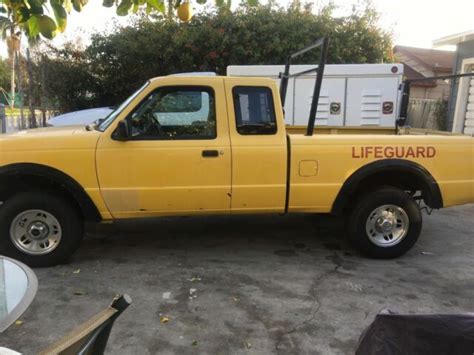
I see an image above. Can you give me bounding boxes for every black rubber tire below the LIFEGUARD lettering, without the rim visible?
[347,187,422,259]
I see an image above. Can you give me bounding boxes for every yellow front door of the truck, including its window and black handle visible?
[96,77,231,218]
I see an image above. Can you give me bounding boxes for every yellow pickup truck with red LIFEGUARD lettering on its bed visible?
[0,39,474,266]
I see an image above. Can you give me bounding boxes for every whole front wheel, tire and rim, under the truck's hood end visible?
[0,191,83,267]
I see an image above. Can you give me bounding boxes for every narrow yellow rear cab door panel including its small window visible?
[225,78,287,213]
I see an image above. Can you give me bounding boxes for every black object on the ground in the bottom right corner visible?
[356,310,474,355]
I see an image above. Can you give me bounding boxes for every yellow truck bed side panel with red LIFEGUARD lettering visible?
[289,134,474,213]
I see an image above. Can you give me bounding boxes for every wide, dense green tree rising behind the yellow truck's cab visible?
[86,5,392,104]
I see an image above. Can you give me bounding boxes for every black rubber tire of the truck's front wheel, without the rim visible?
[0,191,84,267]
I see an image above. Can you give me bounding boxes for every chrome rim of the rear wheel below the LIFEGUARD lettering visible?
[365,205,409,248]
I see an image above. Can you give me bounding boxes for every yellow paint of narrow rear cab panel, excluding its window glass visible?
[225,78,287,212]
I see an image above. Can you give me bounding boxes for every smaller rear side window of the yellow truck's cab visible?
[233,86,277,135]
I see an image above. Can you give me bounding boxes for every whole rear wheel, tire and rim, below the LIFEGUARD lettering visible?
[348,187,422,259]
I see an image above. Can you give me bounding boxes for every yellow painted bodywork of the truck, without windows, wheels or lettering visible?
[0,77,474,220]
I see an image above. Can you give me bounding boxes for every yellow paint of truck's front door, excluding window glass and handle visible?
[97,77,231,218]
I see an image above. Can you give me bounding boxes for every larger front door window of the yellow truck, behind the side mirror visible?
[128,87,216,140]
